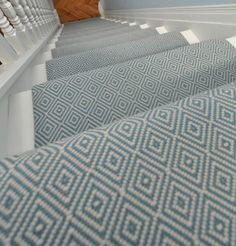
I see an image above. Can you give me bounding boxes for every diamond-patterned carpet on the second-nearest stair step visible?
[33,40,236,147]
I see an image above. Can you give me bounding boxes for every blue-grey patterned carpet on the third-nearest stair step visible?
[46,32,188,80]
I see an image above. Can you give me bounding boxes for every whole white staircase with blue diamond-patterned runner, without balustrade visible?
[0,18,236,246]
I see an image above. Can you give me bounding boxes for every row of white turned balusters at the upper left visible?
[0,0,59,64]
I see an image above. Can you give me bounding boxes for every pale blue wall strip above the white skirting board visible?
[101,0,236,10]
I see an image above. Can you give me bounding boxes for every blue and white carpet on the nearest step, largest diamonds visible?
[0,81,236,246]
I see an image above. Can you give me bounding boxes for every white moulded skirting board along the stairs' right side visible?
[104,4,236,41]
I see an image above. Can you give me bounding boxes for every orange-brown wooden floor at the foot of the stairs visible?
[54,0,99,23]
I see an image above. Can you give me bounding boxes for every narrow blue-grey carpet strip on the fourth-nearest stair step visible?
[52,29,158,58]
